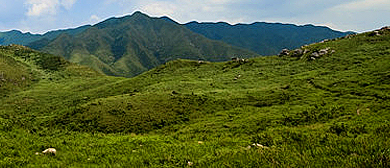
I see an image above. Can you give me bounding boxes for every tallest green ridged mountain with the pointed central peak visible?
[28,12,259,76]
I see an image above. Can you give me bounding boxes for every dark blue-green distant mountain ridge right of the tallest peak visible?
[184,22,353,55]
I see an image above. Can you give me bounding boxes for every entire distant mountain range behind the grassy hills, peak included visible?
[0,12,351,77]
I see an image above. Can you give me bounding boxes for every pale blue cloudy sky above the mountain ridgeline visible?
[0,0,390,33]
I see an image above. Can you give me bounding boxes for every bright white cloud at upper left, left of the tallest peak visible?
[25,0,77,17]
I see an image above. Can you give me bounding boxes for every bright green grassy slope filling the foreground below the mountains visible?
[0,29,390,167]
